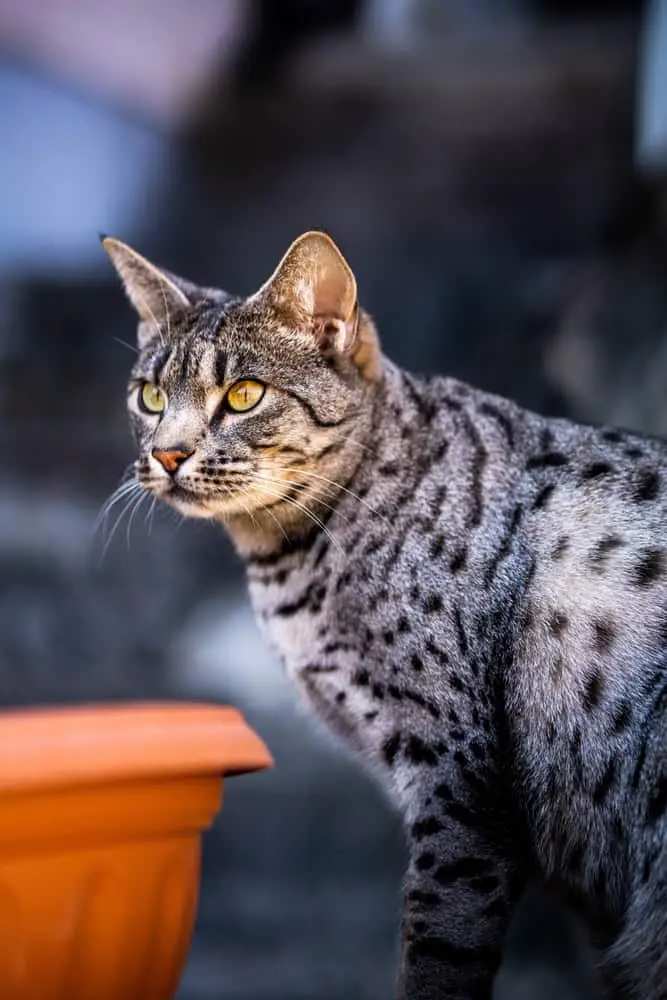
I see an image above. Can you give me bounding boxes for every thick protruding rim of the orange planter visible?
[0,702,273,792]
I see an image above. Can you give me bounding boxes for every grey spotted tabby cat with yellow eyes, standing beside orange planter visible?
[103,232,667,1000]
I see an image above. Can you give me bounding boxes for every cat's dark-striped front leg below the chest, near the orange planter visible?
[399,810,525,1000]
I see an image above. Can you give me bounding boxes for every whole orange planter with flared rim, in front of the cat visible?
[0,704,271,1000]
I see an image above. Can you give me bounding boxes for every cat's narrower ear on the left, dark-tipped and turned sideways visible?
[100,236,191,347]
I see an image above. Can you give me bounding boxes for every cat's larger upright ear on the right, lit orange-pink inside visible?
[257,232,379,377]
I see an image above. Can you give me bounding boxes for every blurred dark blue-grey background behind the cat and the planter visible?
[0,0,667,1000]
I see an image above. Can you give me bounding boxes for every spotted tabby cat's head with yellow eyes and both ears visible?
[103,232,382,548]
